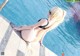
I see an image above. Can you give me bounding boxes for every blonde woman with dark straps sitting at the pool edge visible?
[10,7,66,45]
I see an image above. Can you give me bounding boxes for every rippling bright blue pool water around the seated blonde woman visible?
[0,0,80,56]
